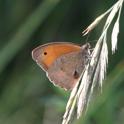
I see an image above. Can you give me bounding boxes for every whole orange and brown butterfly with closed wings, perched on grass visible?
[32,42,90,90]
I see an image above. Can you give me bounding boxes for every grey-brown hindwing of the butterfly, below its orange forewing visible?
[47,50,87,90]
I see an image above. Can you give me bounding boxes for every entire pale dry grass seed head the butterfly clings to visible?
[62,0,124,124]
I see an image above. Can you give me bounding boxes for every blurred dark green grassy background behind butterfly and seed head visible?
[0,0,124,124]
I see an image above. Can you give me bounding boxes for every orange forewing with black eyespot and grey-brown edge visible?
[32,42,81,71]
